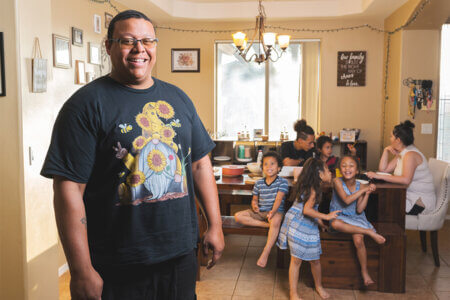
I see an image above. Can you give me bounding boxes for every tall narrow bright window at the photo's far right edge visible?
[437,24,450,162]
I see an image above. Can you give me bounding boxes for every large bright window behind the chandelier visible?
[216,42,303,140]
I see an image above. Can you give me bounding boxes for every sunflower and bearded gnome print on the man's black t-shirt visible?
[114,100,191,205]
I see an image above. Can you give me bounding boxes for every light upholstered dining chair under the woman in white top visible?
[405,158,450,267]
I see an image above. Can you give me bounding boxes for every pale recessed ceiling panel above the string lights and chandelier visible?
[119,0,408,22]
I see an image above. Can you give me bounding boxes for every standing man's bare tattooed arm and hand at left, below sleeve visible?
[53,176,103,300]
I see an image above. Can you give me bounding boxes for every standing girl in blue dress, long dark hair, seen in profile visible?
[277,158,339,300]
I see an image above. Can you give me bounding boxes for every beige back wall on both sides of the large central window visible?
[155,19,383,168]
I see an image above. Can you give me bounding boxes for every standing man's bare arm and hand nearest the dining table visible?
[192,155,225,269]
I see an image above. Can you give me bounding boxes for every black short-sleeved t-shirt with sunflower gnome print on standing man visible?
[41,76,214,269]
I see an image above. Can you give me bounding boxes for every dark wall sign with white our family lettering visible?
[338,51,367,86]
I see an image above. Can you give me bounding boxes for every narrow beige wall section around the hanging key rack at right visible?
[400,30,441,158]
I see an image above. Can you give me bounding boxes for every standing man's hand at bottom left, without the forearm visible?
[70,268,103,300]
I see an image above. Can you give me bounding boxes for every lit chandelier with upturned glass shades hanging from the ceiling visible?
[232,0,290,64]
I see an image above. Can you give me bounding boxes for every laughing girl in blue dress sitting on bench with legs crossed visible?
[330,156,386,286]
